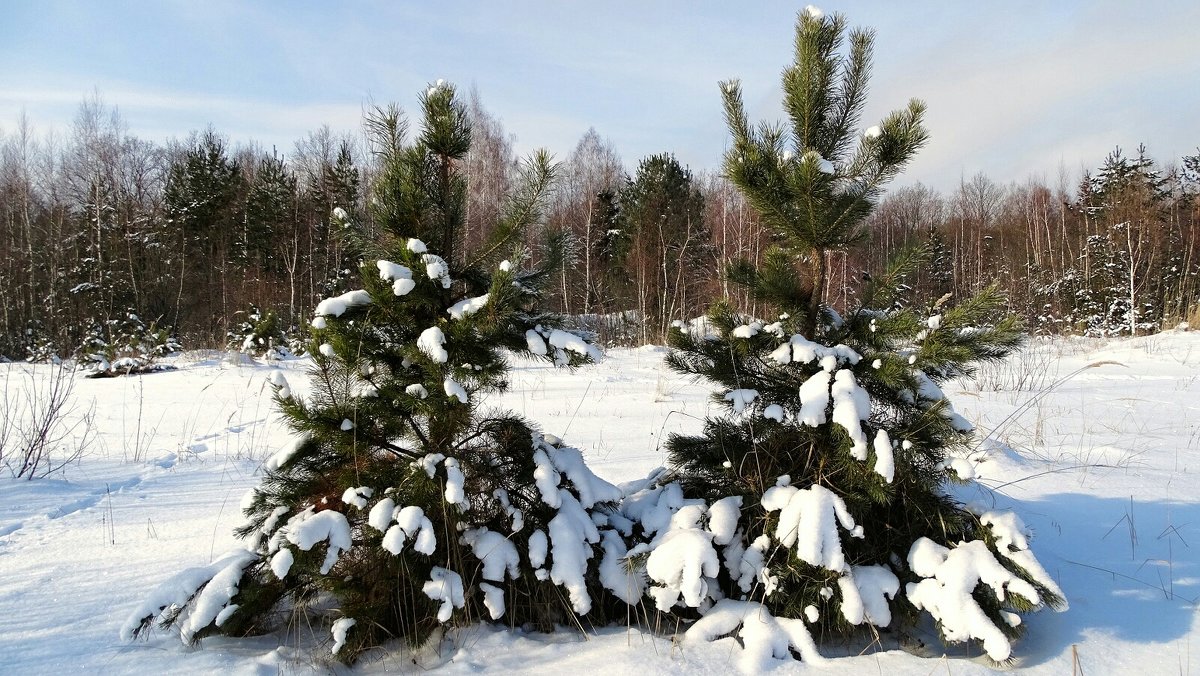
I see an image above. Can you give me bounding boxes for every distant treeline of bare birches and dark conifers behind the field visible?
[0,95,1200,359]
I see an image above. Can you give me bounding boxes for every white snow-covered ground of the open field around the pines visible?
[0,333,1200,676]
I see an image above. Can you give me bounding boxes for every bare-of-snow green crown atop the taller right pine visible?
[721,12,929,334]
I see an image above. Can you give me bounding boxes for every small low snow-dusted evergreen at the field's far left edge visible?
[76,311,182,378]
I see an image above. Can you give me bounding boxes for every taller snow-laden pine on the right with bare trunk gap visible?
[624,6,1064,670]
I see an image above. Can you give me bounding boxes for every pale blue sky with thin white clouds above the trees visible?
[0,0,1200,190]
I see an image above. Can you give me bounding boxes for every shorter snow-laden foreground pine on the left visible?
[124,82,620,660]
